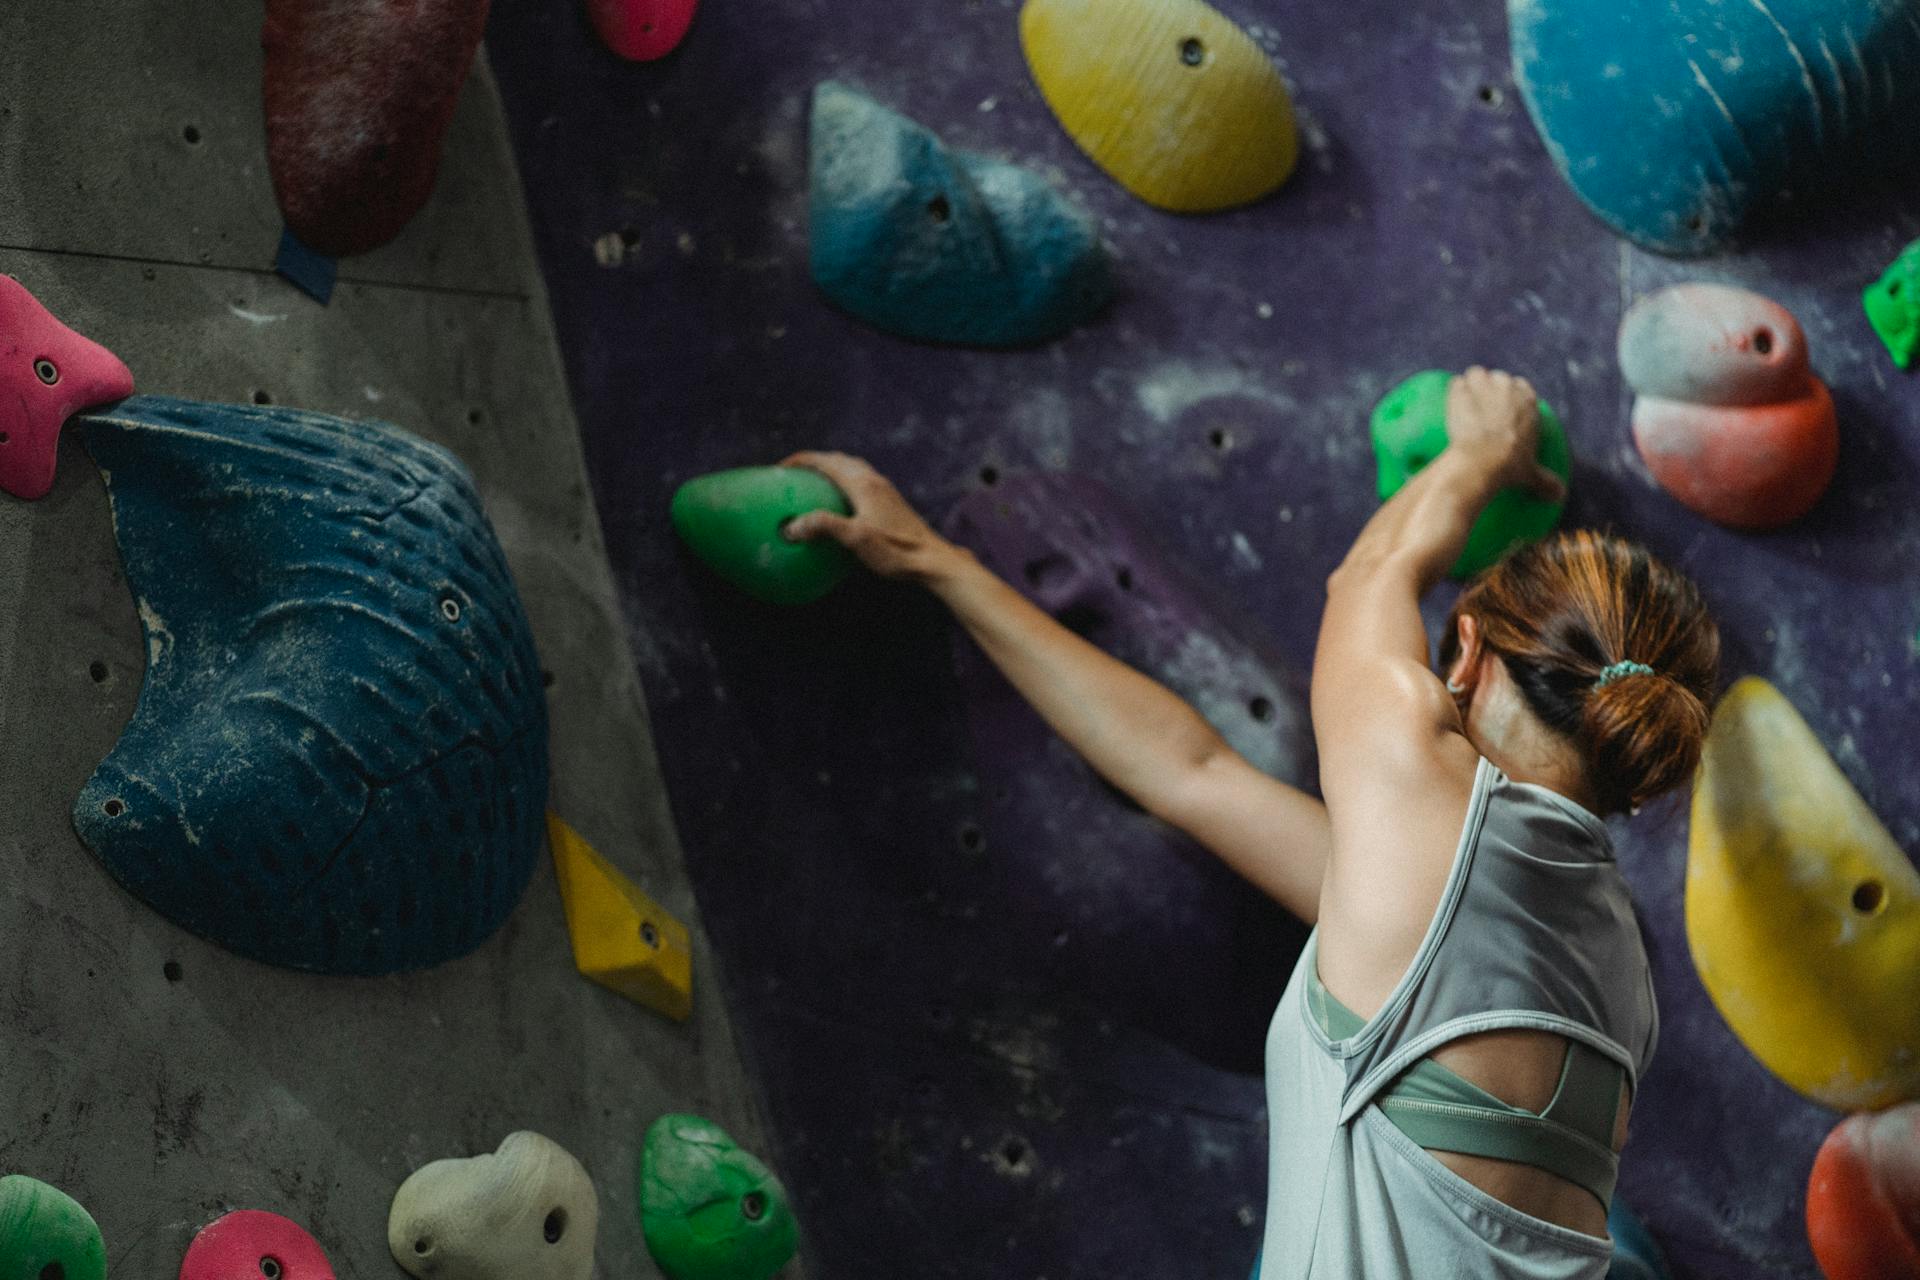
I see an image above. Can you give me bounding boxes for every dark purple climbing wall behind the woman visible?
[490,0,1920,1280]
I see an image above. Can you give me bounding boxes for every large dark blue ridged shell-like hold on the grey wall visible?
[73,395,547,973]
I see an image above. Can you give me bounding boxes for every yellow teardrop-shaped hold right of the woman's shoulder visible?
[1686,677,1920,1111]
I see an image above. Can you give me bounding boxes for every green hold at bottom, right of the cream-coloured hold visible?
[639,1115,799,1280]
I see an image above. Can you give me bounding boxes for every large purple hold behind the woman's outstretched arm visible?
[943,472,1315,1071]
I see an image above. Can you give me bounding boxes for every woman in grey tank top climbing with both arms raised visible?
[789,368,1718,1280]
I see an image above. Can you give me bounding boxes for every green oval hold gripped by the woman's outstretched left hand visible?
[672,466,852,604]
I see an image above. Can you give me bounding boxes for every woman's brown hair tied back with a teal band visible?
[1440,530,1720,814]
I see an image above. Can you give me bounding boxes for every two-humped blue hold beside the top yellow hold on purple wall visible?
[808,81,1114,347]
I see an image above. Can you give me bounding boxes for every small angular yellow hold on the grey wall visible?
[547,814,693,1021]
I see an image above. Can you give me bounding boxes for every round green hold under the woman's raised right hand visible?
[1373,368,1572,578]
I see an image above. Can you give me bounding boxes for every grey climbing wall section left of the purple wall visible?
[0,0,797,1276]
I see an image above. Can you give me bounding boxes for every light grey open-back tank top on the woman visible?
[1260,760,1659,1280]
